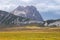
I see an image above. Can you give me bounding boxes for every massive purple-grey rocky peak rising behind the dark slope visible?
[12,6,43,21]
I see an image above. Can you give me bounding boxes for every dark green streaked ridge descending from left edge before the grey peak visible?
[0,10,30,26]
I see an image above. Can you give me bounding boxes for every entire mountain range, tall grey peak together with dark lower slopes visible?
[0,6,60,25]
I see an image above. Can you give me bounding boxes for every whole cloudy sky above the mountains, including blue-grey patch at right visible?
[0,0,60,20]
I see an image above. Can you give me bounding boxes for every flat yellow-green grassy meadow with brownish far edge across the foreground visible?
[0,26,60,40]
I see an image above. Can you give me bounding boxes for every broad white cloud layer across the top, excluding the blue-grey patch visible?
[0,0,60,12]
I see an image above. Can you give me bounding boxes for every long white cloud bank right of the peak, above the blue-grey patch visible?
[36,3,60,12]
